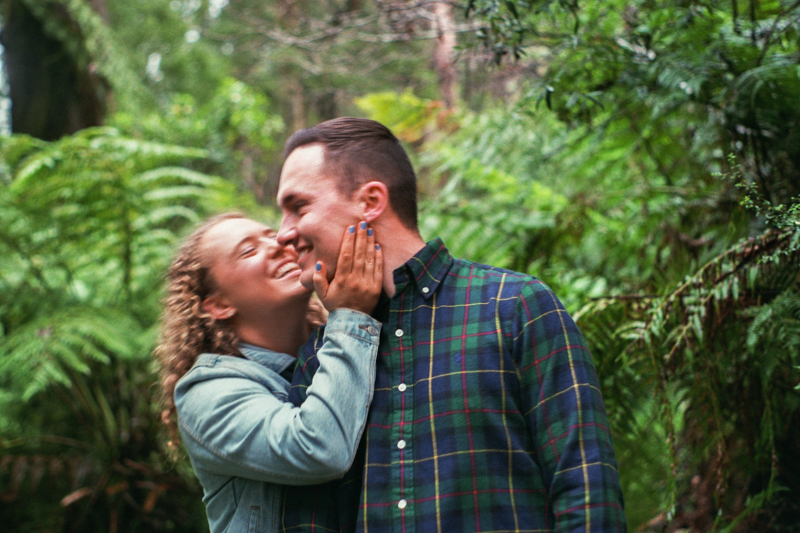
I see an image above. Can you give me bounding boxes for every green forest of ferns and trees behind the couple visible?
[0,0,800,533]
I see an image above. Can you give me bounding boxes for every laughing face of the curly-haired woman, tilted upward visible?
[200,218,311,323]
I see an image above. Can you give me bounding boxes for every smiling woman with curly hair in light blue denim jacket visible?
[156,213,382,533]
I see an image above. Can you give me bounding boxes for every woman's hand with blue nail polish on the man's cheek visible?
[314,222,383,314]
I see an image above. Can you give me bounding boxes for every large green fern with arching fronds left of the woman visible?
[0,128,244,531]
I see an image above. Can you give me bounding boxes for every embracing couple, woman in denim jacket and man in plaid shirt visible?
[157,118,626,533]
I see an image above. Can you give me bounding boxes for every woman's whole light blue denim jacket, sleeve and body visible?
[175,309,381,533]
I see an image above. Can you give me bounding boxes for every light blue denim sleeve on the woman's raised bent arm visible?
[175,309,381,485]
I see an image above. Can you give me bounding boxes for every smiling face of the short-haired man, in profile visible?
[278,144,360,288]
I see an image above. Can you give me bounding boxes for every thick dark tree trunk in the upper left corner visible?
[0,0,108,141]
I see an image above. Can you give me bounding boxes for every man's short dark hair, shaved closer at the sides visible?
[283,117,417,229]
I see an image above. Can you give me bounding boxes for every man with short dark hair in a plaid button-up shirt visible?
[278,118,626,533]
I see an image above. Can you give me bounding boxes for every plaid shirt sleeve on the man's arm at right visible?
[513,280,626,532]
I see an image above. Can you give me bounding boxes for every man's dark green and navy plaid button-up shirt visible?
[282,239,626,533]
